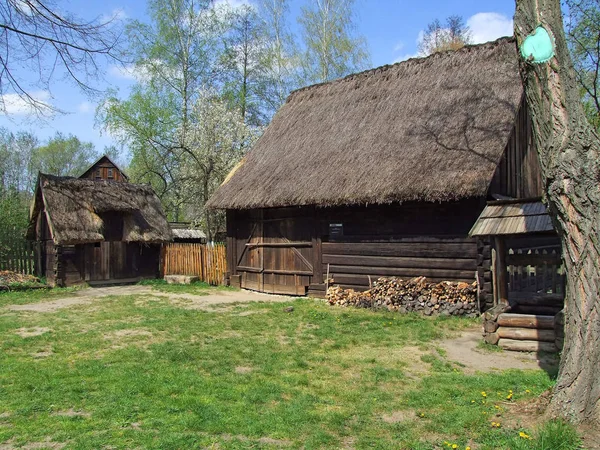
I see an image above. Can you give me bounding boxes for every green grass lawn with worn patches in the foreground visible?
[0,285,577,450]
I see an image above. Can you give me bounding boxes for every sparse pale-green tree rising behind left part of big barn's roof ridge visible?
[298,0,369,83]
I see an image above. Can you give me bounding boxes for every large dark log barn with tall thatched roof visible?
[208,38,542,306]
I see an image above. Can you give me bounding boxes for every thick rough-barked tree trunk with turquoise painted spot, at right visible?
[515,0,600,423]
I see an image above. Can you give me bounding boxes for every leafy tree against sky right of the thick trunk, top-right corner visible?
[565,0,600,130]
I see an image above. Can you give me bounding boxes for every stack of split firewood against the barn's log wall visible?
[327,277,479,317]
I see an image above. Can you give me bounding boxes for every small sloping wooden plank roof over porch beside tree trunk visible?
[469,199,554,236]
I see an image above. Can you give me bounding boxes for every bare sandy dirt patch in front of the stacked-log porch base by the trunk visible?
[440,327,558,373]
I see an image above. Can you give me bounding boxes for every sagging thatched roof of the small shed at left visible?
[27,173,172,245]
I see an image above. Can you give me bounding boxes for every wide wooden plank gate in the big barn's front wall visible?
[236,210,313,295]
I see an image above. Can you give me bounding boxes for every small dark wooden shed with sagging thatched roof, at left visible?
[27,174,172,286]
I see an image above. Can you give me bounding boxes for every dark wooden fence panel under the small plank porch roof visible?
[506,248,565,295]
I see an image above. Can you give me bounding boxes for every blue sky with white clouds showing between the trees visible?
[0,0,515,160]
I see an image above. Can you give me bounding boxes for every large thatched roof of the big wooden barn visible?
[208,38,523,209]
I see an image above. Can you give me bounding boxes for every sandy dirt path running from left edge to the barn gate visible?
[6,285,295,313]
